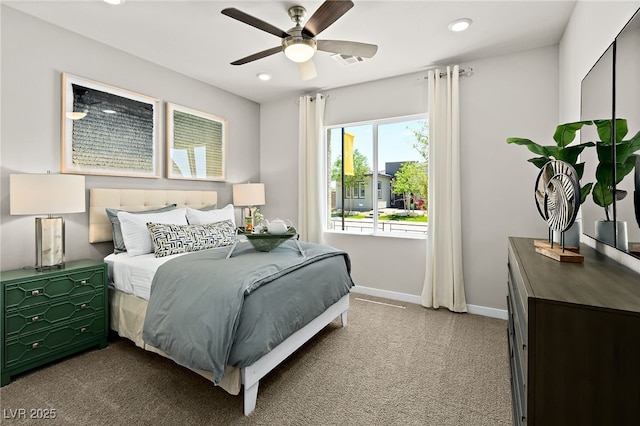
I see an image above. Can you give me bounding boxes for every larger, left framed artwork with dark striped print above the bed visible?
[60,73,160,178]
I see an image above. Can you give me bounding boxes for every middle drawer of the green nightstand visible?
[5,291,105,338]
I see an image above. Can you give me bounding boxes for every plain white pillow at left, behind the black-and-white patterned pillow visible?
[118,209,188,256]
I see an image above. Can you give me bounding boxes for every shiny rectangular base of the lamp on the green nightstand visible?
[36,217,64,271]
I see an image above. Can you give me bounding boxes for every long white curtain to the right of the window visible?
[422,65,467,312]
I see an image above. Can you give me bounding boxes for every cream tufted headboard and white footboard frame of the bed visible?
[89,188,349,416]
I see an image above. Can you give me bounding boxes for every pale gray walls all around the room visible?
[5,1,640,309]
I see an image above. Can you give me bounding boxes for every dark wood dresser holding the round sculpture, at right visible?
[507,237,640,426]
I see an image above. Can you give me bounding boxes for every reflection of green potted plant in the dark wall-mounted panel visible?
[592,118,640,250]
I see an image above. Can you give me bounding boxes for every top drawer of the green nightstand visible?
[4,267,104,312]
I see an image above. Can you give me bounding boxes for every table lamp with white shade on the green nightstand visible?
[9,173,85,271]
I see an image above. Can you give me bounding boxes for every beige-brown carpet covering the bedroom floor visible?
[0,294,511,426]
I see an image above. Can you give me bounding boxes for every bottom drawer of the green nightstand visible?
[4,314,106,368]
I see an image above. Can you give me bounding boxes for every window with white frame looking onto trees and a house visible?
[326,116,429,235]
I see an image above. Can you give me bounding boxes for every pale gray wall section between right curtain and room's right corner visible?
[460,46,558,309]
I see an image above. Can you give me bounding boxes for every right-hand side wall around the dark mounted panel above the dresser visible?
[559,0,640,271]
